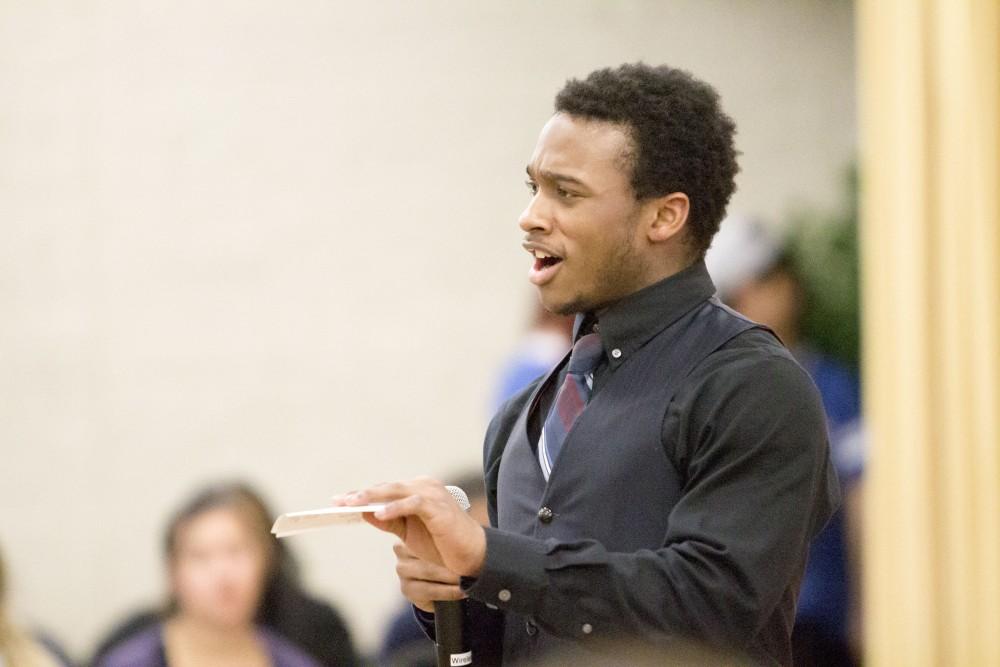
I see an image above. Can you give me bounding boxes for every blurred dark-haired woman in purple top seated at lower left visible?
[94,483,357,667]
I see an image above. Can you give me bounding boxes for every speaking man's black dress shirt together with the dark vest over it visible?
[418,262,838,664]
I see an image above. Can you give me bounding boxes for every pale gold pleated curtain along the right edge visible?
[857,0,1000,666]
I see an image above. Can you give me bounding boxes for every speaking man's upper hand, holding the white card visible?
[334,477,486,577]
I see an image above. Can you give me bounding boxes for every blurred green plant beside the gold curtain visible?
[789,166,861,369]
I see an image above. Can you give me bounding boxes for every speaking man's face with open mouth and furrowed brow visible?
[518,113,646,314]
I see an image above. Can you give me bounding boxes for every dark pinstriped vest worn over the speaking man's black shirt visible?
[484,298,759,664]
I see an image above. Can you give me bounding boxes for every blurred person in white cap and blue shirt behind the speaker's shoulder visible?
[705,216,863,667]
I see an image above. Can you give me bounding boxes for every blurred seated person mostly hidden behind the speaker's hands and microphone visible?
[378,471,490,667]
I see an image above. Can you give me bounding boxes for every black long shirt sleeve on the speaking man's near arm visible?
[464,351,837,660]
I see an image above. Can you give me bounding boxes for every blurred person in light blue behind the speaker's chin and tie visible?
[490,301,573,414]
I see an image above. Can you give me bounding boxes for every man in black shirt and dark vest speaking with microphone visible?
[338,64,837,665]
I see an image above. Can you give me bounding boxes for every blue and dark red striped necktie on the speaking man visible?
[538,333,604,481]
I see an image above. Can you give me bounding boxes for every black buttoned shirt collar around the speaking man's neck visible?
[573,260,715,368]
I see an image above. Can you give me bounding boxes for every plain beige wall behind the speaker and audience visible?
[0,0,854,654]
